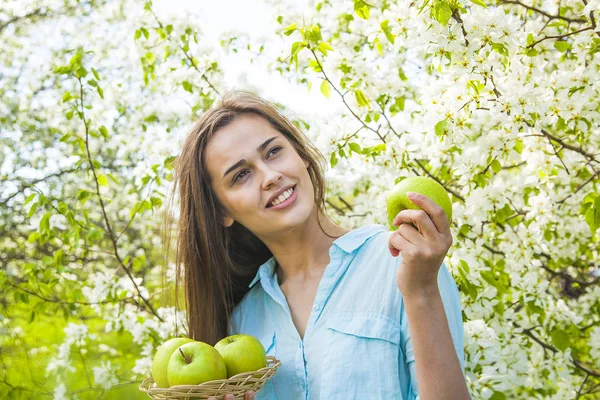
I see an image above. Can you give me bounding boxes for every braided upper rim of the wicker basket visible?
[139,356,281,395]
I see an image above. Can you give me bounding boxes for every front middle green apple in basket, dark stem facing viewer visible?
[167,341,227,386]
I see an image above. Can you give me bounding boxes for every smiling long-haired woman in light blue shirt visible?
[166,92,469,400]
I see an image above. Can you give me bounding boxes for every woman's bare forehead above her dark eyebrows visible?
[205,114,283,181]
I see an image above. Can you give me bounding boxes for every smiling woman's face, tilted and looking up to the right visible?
[205,114,315,237]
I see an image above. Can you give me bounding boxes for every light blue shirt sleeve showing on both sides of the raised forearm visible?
[401,263,465,400]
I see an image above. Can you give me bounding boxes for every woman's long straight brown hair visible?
[163,91,340,345]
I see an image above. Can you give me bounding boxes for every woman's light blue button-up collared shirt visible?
[229,224,464,400]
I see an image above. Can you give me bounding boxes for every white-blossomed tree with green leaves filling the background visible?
[0,0,600,400]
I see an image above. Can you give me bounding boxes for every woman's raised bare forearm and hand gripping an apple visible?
[388,195,470,400]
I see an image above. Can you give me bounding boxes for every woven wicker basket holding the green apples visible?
[140,356,281,400]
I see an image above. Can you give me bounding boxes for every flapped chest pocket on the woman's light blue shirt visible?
[321,313,402,399]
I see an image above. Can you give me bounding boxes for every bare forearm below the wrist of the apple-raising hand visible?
[404,287,470,400]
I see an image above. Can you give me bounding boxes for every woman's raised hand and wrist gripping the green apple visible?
[388,193,452,297]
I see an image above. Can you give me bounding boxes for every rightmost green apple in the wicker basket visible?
[215,334,267,377]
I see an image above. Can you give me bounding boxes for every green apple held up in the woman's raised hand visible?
[387,176,452,231]
